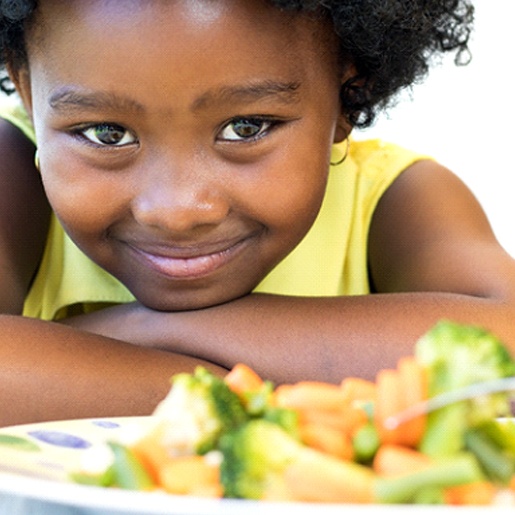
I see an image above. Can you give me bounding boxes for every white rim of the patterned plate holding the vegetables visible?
[0,415,513,515]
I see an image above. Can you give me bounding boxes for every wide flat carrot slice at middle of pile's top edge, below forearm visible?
[275,381,347,410]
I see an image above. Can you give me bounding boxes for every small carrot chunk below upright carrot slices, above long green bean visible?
[372,444,432,476]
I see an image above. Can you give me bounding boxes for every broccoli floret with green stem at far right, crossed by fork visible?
[415,321,515,455]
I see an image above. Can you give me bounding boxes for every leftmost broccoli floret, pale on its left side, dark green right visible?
[154,367,248,454]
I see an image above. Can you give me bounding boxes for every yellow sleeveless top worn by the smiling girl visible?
[0,100,425,320]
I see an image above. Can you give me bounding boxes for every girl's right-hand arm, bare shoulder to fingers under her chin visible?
[65,161,515,382]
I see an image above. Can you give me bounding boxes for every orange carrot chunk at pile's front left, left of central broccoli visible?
[159,456,223,497]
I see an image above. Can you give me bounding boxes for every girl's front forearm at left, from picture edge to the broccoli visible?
[0,315,225,426]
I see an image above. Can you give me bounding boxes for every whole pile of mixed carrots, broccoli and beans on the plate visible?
[72,321,515,505]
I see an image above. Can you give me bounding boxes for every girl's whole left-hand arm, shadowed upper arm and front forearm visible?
[0,120,225,425]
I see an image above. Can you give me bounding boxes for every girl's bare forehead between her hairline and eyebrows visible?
[24,0,339,118]
